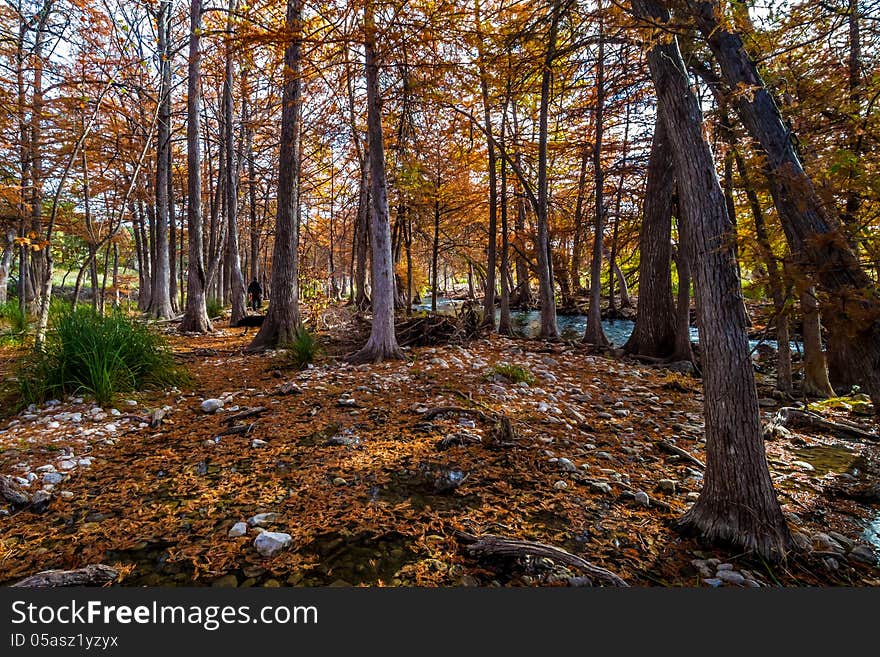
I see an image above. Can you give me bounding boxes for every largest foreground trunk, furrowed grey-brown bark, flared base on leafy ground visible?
[631,0,791,559]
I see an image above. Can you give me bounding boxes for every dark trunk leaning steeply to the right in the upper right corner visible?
[687,0,880,413]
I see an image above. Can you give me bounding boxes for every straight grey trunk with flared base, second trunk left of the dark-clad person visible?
[180,0,214,333]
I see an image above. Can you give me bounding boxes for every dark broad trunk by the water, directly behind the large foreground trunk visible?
[623,113,676,358]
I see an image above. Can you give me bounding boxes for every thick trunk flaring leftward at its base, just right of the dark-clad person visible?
[248,0,303,351]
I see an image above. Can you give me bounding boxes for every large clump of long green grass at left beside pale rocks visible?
[18,306,186,404]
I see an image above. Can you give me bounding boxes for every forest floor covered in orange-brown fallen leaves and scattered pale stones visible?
[0,310,880,586]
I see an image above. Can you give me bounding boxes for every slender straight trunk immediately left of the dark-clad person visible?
[223,0,247,325]
